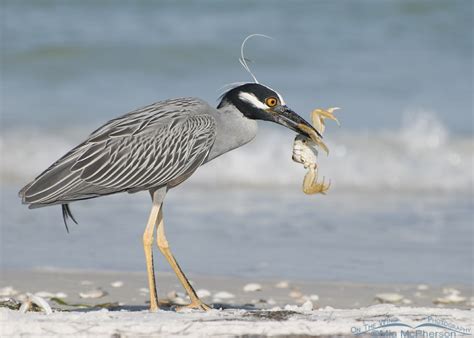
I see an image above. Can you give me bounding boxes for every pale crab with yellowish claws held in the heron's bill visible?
[292,107,339,195]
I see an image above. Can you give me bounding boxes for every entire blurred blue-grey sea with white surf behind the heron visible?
[0,0,474,283]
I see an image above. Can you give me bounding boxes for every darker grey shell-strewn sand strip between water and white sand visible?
[0,269,473,309]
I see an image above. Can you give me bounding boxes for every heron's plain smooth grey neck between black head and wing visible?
[208,104,258,161]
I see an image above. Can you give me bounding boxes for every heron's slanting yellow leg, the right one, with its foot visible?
[157,210,211,311]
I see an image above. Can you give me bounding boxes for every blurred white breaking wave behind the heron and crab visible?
[0,112,474,192]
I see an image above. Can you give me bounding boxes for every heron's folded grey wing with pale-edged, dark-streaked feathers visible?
[20,98,215,206]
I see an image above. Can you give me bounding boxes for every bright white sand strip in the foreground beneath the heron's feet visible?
[0,304,473,337]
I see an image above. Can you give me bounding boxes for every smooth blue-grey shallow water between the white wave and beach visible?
[1,184,474,285]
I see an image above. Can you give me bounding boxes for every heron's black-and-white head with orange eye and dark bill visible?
[217,83,321,137]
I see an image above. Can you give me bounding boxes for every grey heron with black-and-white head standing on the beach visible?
[20,83,320,310]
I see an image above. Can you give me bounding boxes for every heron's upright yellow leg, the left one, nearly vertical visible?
[143,203,161,311]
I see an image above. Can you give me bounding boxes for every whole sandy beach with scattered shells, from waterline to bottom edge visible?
[0,269,473,337]
